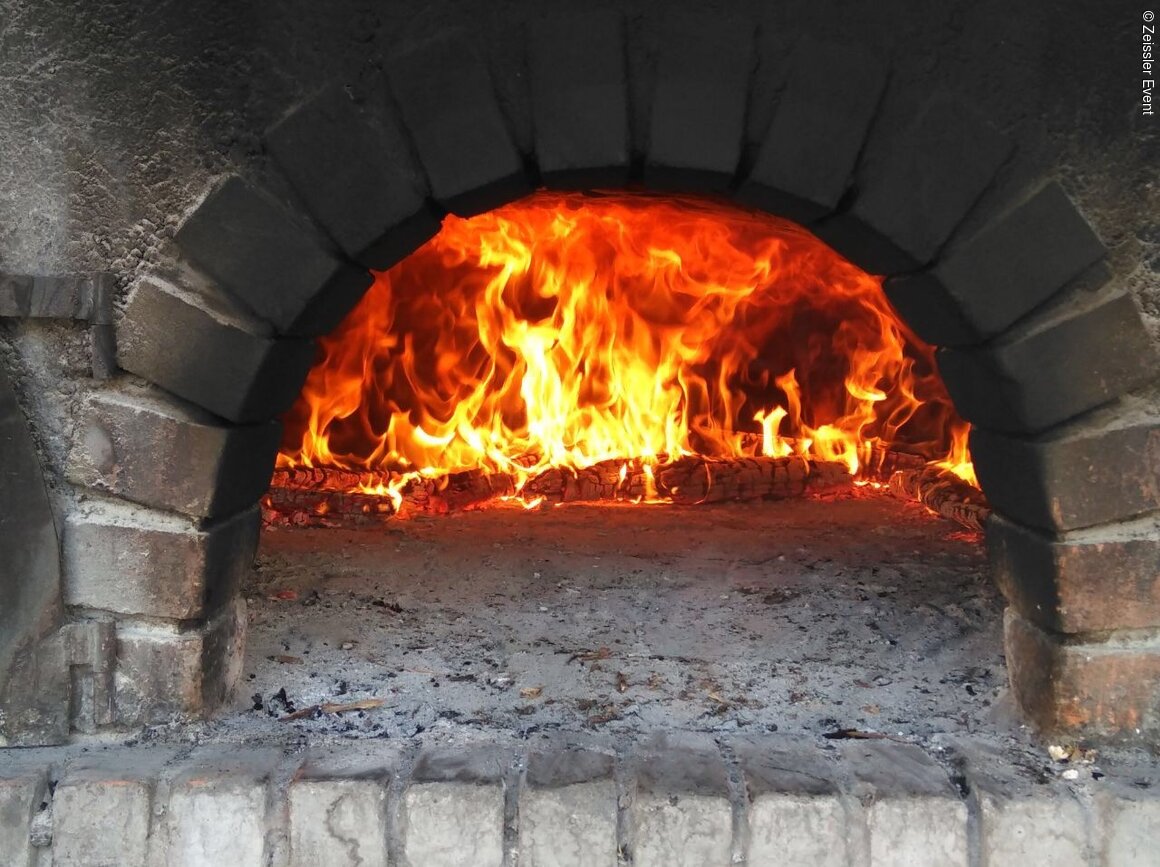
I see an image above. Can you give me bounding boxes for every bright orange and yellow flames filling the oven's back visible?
[278,193,973,501]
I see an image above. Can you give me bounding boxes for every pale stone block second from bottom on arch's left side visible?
[64,501,261,620]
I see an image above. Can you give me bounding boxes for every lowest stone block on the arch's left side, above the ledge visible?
[114,599,246,725]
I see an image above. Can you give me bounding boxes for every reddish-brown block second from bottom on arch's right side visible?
[987,513,1160,633]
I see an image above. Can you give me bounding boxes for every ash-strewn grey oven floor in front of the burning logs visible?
[194,496,1013,739]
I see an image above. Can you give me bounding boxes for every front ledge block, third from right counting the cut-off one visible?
[841,740,967,867]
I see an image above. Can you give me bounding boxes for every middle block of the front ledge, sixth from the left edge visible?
[520,749,617,867]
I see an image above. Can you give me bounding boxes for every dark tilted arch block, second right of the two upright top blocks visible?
[814,96,1012,274]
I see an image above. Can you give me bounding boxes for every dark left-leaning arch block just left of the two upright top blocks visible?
[387,37,531,217]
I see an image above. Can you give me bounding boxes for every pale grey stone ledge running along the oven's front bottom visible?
[0,735,1160,867]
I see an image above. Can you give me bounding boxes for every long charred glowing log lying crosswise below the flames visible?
[263,456,851,525]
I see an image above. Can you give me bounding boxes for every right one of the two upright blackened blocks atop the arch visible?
[644,13,755,192]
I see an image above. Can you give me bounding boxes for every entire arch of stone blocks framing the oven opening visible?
[65,13,1160,737]
